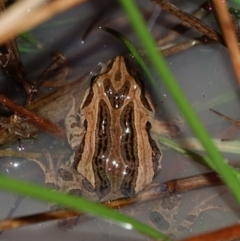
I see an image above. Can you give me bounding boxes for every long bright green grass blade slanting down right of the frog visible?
[119,0,240,203]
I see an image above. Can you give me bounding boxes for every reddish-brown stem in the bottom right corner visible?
[181,224,240,241]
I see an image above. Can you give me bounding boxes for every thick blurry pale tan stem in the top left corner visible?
[0,0,86,44]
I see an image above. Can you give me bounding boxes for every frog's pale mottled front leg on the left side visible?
[64,97,84,150]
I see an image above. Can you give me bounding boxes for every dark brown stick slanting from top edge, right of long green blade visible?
[151,0,225,45]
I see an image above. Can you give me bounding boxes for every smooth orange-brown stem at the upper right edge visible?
[212,0,240,84]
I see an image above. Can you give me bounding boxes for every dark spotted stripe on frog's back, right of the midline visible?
[120,101,139,196]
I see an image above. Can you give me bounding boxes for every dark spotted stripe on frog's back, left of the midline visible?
[92,100,112,199]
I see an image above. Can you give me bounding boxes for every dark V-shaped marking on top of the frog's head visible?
[103,78,131,109]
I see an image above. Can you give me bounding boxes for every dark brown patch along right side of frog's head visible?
[124,58,153,111]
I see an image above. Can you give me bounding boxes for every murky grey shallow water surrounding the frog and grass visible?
[0,0,240,241]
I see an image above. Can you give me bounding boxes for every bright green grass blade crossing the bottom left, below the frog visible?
[0,176,170,241]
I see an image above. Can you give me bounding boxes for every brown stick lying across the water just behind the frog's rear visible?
[0,172,223,230]
